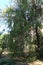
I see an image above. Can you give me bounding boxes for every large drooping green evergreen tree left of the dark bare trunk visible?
[6,0,31,56]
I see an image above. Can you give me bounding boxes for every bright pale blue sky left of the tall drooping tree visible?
[0,0,11,33]
